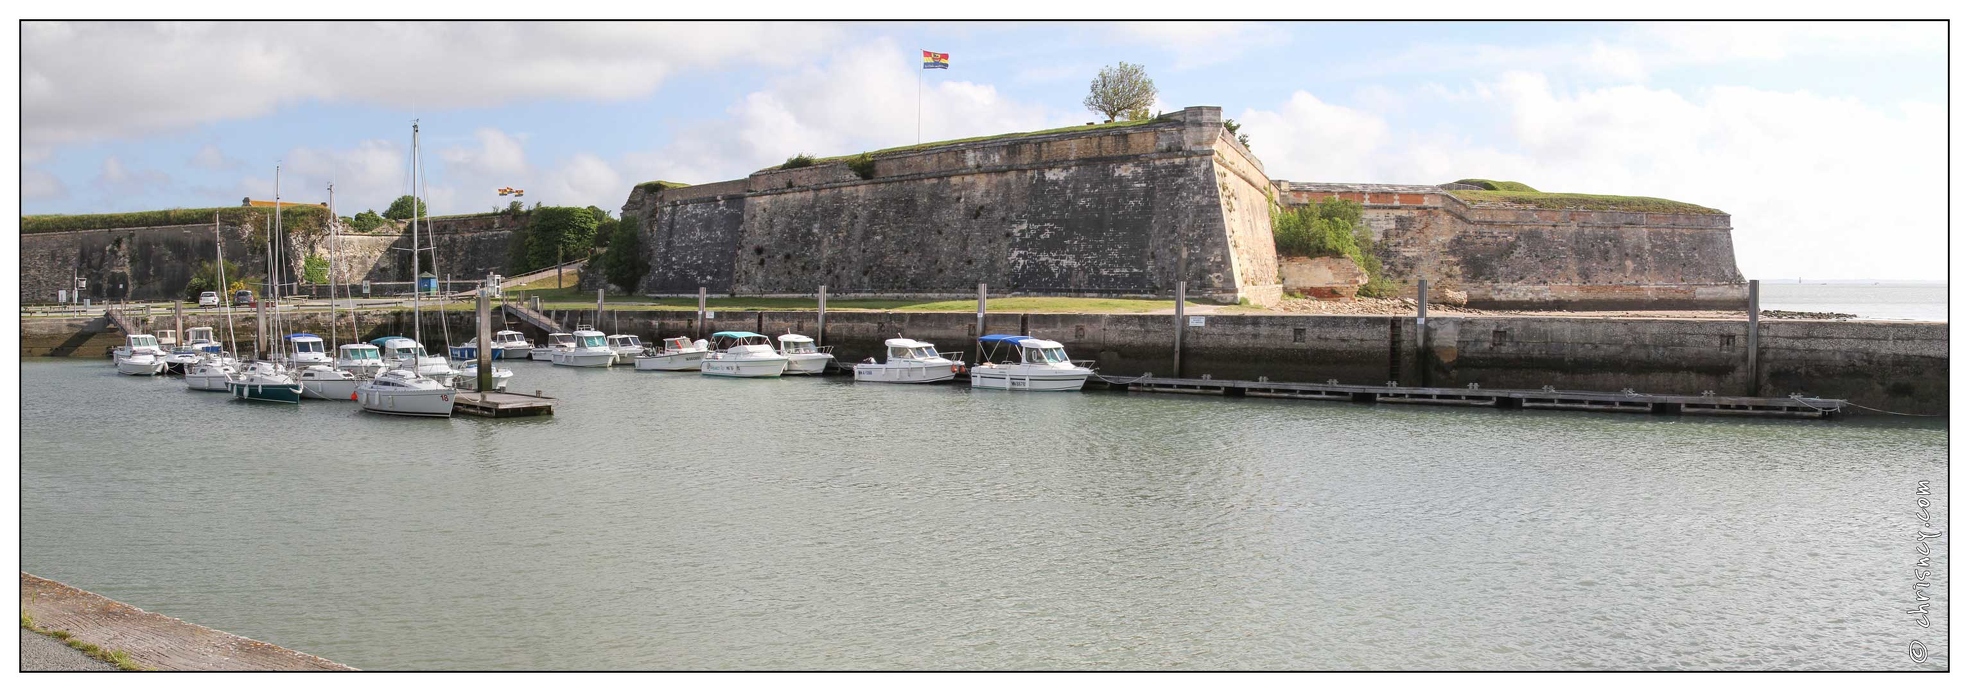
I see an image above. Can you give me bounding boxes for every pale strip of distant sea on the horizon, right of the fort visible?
[1758,278,1949,321]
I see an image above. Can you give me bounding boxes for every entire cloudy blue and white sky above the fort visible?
[22,22,1947,278]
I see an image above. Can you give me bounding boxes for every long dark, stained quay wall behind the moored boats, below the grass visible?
[22,310,1949,414]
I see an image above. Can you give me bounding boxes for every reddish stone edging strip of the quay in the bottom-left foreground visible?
[20,572,354,670]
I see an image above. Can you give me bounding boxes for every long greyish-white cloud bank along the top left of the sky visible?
[22,22,839,146]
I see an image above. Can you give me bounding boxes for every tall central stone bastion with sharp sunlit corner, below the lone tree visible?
[622,108,1278,300]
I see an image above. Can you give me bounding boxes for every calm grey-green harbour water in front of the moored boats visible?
[22,359,1947,670]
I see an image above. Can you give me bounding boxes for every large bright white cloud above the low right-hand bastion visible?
[1239,73,1947,278]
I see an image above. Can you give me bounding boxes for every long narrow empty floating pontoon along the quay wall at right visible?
[1087,375,1847,418]
